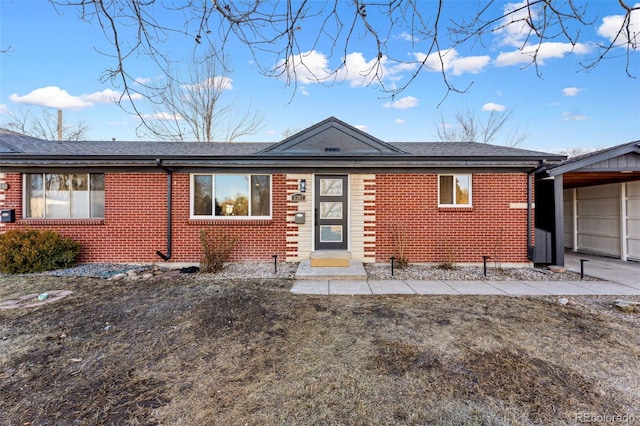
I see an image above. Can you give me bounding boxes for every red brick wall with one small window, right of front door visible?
[375,174,527,262]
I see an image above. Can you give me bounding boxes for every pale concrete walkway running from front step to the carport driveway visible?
[291,253,640,296]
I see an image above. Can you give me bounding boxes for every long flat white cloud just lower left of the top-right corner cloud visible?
[494,42,591,67]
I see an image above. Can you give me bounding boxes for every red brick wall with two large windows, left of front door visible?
[3,173,287,262]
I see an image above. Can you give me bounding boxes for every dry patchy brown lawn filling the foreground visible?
[0,276,640,425]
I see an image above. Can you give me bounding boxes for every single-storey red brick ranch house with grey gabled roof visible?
[0,117,564,265]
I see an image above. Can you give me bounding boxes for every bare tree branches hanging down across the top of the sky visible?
[49,0,640,109]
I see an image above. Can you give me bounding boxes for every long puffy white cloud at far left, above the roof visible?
[9,86,142,110]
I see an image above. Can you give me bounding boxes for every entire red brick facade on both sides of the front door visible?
[0,173,527,263]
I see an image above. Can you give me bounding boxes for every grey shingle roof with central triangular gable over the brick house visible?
[0,117,564,168]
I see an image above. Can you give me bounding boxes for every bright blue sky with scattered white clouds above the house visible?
[0,0,640,151]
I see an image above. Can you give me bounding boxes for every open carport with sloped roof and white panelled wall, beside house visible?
[534,141,640,265]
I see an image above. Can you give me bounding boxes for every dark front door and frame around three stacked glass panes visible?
[313,174,350,251]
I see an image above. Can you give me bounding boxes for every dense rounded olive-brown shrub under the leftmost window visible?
[0,229,80,274]
